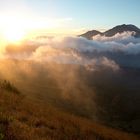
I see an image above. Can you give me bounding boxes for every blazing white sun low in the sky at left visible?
[0,14,26,43]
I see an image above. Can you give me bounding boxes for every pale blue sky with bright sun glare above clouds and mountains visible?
[0,0,140,36]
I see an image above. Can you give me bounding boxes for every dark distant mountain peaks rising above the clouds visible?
[79,24,140,39]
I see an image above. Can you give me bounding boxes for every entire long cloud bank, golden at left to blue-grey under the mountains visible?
[2,32,140,70]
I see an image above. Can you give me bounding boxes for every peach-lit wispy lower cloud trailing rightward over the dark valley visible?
[30,46,119,71]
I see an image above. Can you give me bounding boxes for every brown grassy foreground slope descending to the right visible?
[0,82,138,140]
